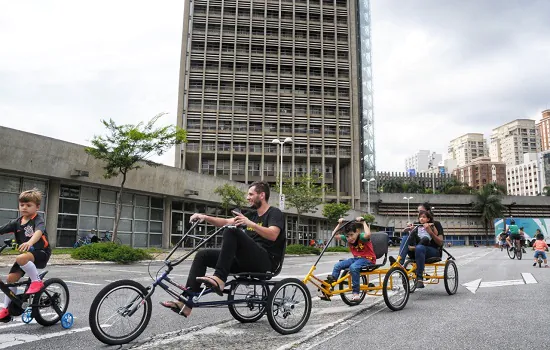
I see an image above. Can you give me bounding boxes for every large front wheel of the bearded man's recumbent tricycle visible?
[88,280,153,345]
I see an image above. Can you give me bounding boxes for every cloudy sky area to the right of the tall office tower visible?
[371,0,550,170]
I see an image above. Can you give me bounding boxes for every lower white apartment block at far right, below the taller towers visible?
[506,153,543,196]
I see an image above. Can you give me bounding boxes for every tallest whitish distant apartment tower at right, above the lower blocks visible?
[489,119,540,166]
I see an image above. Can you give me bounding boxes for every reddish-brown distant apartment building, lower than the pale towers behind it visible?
[454,157,506,190]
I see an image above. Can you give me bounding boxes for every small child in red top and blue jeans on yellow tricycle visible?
[327,217,376,301]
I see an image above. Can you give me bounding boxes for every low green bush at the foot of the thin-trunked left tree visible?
[71,242,151,264]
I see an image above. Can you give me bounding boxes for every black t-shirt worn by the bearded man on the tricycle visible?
[245,207,286,269]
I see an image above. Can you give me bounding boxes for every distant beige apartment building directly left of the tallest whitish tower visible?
[448,133,489,167]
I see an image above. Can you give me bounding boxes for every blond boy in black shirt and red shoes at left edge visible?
[0,188,51,321]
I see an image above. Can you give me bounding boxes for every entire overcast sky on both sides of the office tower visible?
[0,0,550,171]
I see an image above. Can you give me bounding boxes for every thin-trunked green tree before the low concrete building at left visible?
[85,113,187,241]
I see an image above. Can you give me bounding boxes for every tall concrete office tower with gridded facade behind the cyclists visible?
[176,0,375,206]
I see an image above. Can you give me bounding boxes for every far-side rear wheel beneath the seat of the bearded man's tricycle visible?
[227,281,269,323]
